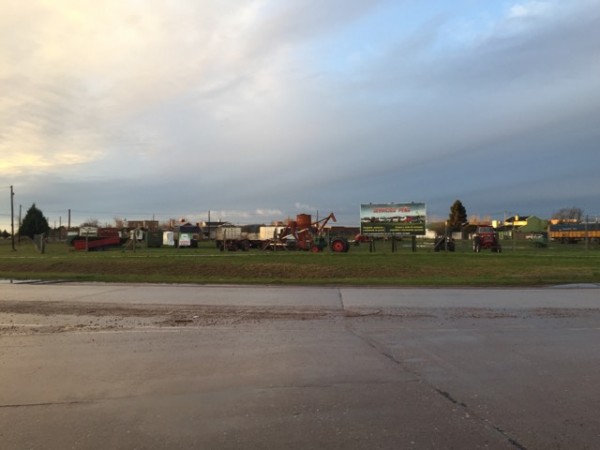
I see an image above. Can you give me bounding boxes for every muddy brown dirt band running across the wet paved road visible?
[0,301,600,336]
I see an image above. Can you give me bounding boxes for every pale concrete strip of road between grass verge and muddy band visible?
[0,283,600,309]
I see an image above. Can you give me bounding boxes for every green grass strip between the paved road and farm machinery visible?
[0,240,600,286]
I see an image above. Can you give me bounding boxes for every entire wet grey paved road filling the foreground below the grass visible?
[0,284,600,449]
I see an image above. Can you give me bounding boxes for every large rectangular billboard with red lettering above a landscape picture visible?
[360,203,427,236]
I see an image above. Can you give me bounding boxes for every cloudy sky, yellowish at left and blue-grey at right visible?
[0,0,600,229]
